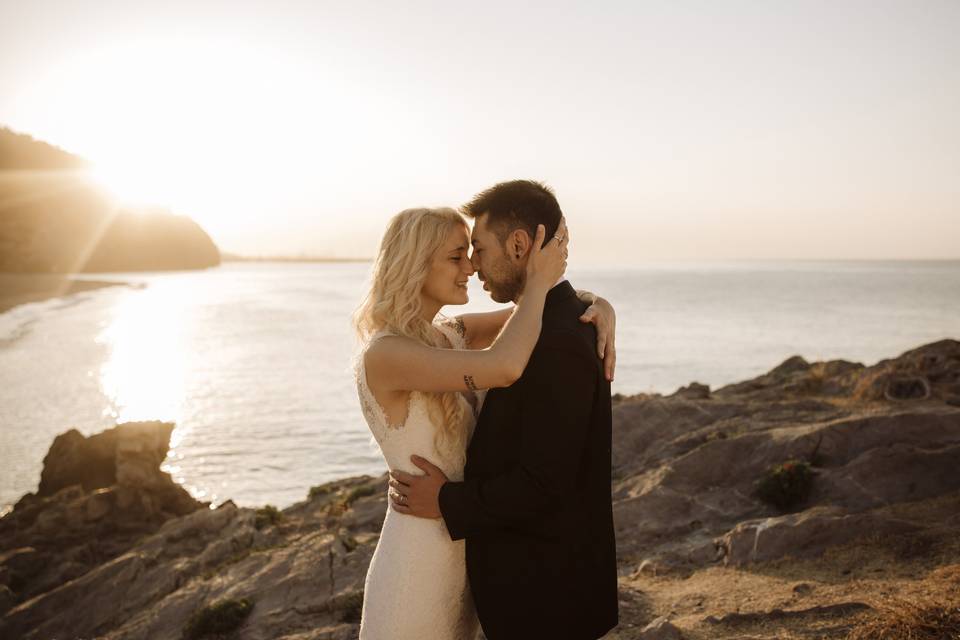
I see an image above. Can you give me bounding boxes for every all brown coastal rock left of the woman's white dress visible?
[0,430,387,639]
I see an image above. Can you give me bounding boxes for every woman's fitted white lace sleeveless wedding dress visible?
[355,324,486,640]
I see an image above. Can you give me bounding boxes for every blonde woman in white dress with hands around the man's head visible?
[354,208,612,640]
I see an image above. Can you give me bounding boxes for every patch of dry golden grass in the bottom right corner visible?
[847,598,960,640]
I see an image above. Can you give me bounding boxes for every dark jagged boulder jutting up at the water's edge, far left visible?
[0,422,209,604]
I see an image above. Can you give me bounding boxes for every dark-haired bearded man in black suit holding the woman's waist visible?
[390,180,618,640]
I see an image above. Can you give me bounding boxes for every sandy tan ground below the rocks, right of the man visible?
[605,497,960,640]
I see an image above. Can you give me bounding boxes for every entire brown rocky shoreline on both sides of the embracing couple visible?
[0,340,960,640]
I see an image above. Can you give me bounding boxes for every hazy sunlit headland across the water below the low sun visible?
[0,129,220,273]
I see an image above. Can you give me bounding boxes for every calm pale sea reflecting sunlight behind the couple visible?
[0,262,960,508]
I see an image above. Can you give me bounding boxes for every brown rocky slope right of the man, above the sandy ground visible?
[614,340,960,571]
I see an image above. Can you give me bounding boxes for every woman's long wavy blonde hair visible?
[353,207,469,463]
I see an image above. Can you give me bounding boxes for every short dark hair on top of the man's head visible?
[462,180,563,250]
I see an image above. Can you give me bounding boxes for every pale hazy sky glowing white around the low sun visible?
[0,0,960,266]
